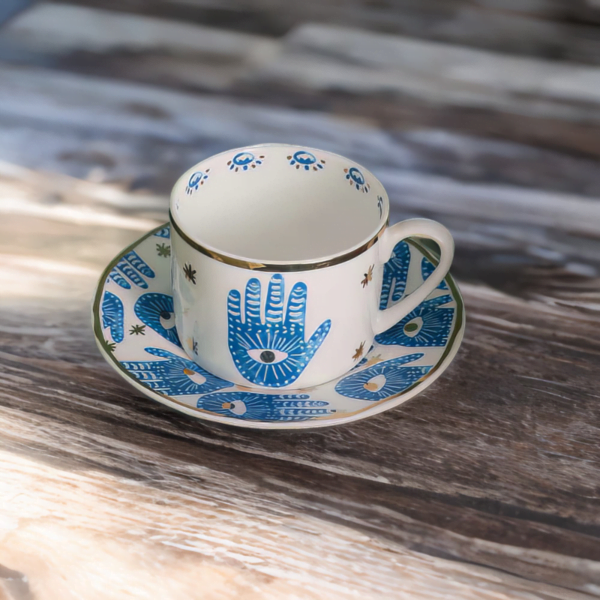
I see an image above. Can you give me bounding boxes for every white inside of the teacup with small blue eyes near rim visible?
[171,144,389,263]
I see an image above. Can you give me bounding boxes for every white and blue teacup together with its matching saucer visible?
[93,144,464,429]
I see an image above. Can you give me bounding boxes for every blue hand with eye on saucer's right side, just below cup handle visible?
[375,294,454,347]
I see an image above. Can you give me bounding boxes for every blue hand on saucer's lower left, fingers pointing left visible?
[121,348,233,396]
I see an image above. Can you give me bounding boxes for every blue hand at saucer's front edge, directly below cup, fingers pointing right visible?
[197,392,335,421]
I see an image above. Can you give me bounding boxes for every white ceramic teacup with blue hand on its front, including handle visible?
[171,144,454,389]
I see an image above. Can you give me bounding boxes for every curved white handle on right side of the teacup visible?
[373,219,454,334]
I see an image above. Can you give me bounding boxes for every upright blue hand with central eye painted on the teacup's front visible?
[227,274,331,387]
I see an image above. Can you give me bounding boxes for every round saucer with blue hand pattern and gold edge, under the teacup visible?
[93,225,465,429]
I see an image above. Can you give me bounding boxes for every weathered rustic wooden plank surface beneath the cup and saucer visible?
[0,0,600,600]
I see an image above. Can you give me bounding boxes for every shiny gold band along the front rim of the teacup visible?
[169,211,389,273]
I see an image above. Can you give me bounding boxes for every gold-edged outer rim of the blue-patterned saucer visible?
[91,221,466,429]
